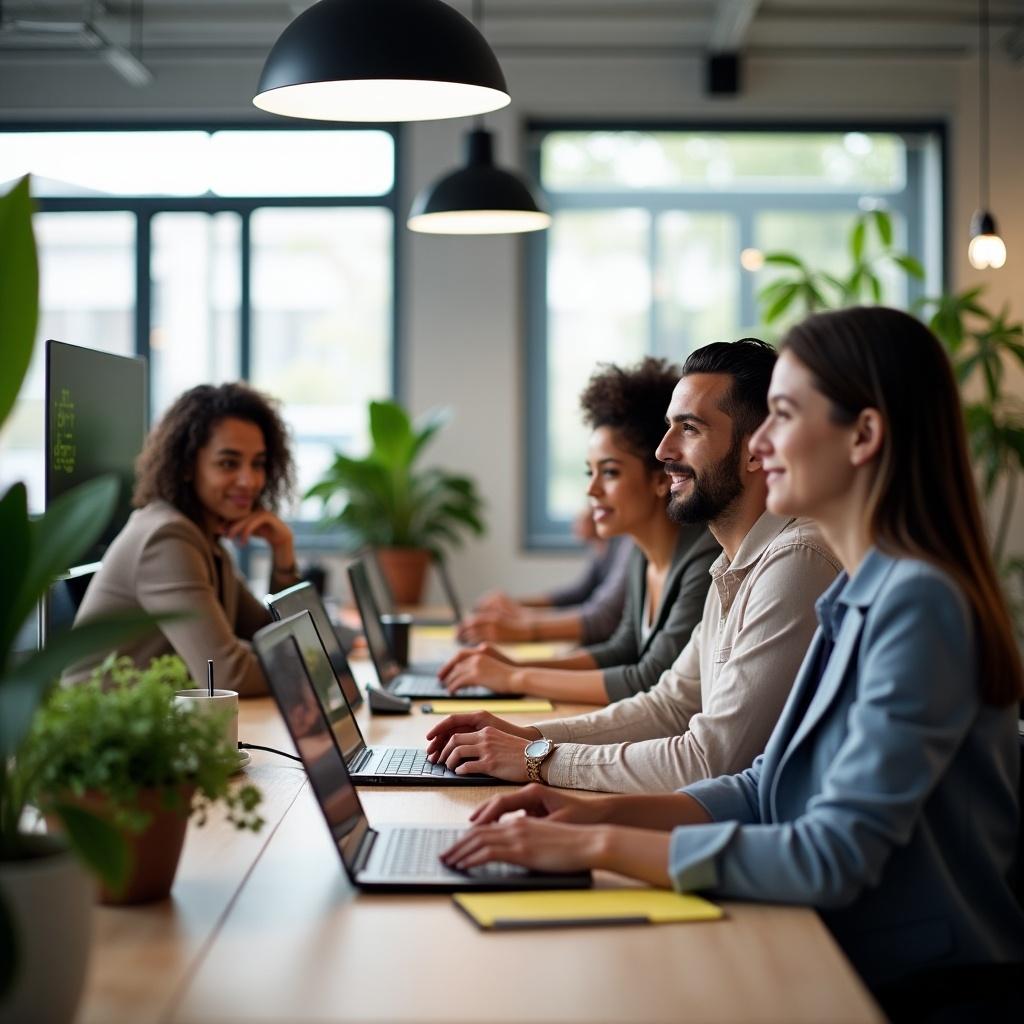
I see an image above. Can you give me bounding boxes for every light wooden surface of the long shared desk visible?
[78,634,883,1024]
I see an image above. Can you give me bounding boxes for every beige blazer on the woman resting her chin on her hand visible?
[70,501,270,696]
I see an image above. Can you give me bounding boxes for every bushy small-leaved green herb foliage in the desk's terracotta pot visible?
[26,654,263,831]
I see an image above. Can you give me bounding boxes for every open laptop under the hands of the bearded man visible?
[253,611,508,785]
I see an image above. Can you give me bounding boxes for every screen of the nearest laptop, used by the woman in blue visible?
[253,622,370,878]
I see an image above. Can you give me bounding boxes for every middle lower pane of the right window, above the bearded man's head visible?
[653,211,739,362]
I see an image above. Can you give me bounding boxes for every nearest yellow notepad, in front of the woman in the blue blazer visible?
[453,889,725,929]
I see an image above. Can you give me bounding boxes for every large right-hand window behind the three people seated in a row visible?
[526,126,941,547]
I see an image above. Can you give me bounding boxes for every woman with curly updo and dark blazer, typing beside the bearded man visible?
[440,357,721,705]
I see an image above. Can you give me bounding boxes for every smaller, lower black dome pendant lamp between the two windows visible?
[408,127,551,234]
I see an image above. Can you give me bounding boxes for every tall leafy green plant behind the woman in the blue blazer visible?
[758,210,1024,571]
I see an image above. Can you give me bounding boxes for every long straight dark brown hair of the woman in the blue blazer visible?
[780,306,1024,707]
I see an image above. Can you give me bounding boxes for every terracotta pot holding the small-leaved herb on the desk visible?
[50,785,196,905]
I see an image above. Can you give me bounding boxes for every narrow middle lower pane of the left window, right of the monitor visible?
[150,213,242,420]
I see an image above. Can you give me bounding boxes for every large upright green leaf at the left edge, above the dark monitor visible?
[0,177,39,430]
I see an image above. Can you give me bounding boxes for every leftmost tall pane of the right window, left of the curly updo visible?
[547,210,651,519]
